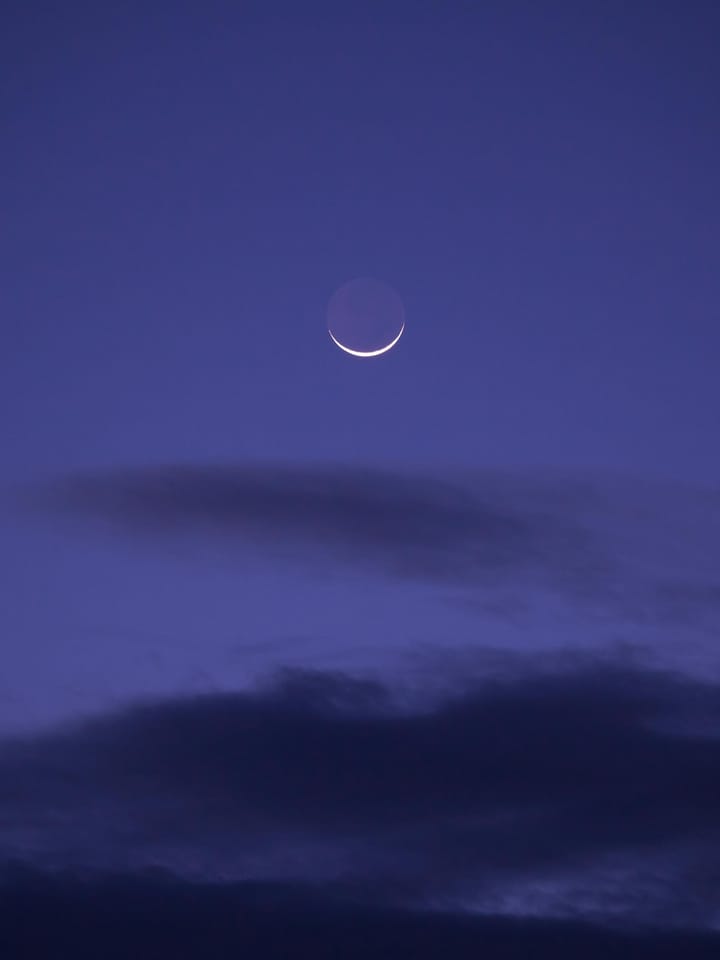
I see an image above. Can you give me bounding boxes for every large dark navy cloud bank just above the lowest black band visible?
[0,663,720,927]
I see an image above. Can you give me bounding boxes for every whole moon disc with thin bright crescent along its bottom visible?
[327,278,405,357]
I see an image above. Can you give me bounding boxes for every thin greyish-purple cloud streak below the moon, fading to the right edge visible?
[32,465,720,631]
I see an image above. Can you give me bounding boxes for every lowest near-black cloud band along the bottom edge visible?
[0,869,720,960]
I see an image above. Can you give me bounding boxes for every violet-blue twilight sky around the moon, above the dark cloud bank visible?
[0,0,720,944]
